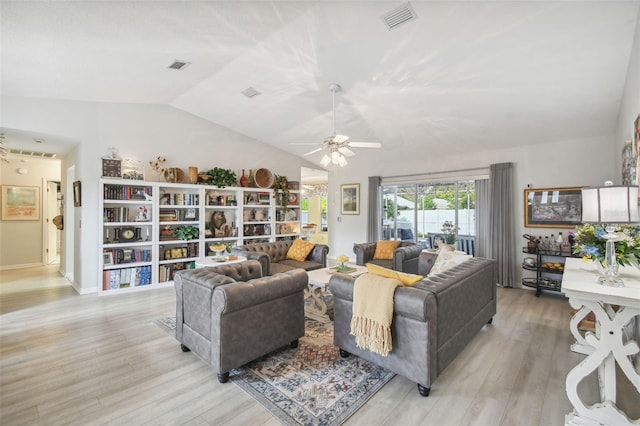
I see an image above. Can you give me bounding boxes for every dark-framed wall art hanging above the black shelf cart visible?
[524,187,582,228]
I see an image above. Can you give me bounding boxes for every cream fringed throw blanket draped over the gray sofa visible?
[351,274,402,356]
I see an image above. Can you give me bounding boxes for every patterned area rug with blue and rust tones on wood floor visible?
[157,318,395,426]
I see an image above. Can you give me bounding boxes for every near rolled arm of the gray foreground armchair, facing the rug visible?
[213,269,309,314]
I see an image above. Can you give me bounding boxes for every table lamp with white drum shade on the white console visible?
[582,181,640,287]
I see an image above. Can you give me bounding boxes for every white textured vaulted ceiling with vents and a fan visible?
[0,0,640,163]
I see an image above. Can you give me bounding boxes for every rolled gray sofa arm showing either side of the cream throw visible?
[329,274,430,322]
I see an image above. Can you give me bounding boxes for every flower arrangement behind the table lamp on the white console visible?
[573,223,640,267]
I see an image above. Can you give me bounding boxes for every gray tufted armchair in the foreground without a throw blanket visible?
[174,260,309,383]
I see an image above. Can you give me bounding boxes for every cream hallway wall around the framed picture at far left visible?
[0,156,60,269]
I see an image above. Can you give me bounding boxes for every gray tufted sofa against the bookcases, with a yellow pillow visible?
[231,240,329,275]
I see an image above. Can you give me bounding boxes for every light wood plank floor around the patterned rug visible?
[0,266,640,426]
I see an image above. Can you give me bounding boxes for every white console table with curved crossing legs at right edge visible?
[562,258,640,425]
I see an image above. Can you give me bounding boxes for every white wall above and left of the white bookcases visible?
[2,97,312,293]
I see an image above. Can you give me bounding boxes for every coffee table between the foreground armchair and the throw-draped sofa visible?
[304,265,367,322]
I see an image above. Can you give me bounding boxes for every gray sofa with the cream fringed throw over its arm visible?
[329,258,496,396]
